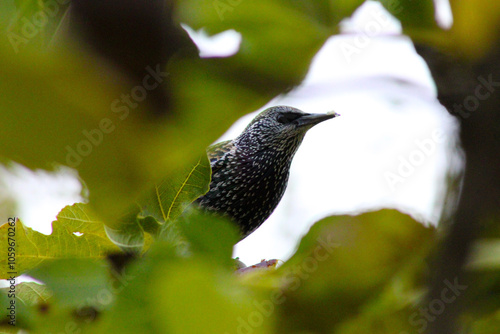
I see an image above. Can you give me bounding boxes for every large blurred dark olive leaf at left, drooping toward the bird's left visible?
[0,44,160,222]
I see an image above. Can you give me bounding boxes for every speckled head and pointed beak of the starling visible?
[238,106,339,147]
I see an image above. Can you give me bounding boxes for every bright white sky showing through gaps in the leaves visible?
[0,1,459,264]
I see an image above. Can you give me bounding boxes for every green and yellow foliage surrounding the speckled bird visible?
[0,0,500,333]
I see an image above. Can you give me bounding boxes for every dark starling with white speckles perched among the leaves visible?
[197,106,339,239]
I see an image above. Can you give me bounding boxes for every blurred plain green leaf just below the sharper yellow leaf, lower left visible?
[28,258,114,308]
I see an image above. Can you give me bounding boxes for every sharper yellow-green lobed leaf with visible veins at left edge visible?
[0,203,119,278]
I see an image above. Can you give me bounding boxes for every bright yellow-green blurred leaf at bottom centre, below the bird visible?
[151,262,273,333]
